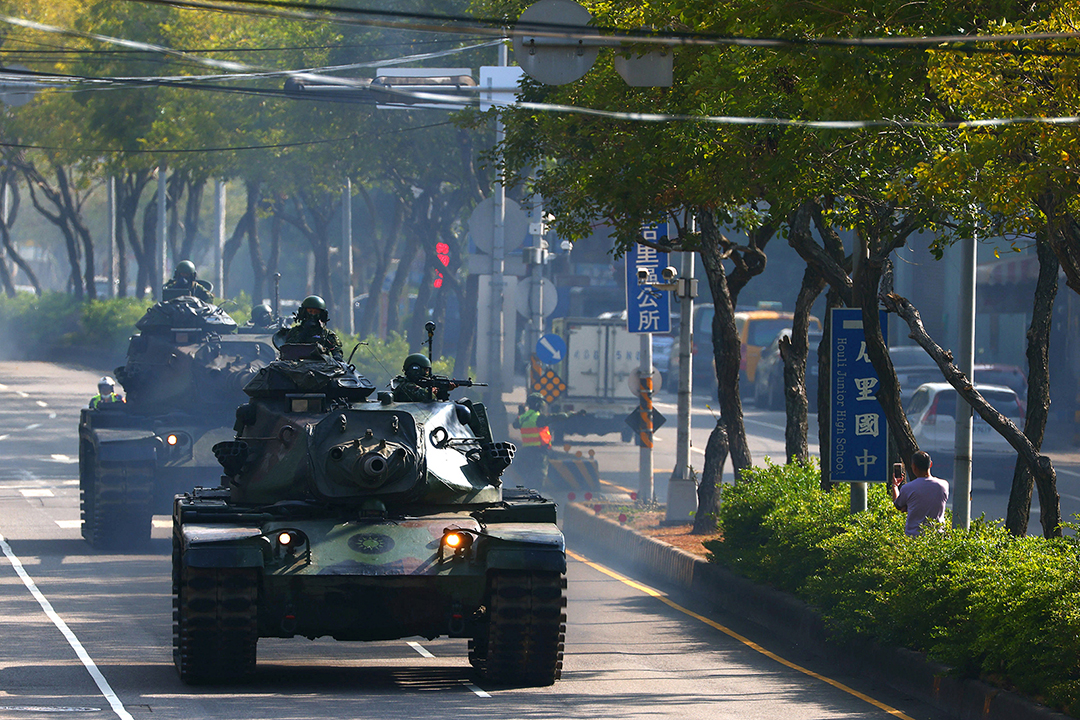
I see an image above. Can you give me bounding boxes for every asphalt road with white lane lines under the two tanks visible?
[0,363,954,720]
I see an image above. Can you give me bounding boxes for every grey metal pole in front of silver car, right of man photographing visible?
[953,237,975,530]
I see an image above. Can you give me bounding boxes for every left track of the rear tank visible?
[79,462,153,551]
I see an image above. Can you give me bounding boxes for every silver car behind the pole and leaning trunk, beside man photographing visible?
[905,382,1023,492]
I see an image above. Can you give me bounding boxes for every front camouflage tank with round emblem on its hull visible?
[173,345,566,685]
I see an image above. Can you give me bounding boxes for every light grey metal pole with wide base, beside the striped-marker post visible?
[664,252,698,525]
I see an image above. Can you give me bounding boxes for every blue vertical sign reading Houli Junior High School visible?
[828,308,890,483]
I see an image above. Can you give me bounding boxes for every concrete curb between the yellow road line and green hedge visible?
[563,503,1069,720]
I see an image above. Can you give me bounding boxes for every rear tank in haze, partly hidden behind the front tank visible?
[79,296,276,549]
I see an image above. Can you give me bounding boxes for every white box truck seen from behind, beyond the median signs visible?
[550,317,642,446]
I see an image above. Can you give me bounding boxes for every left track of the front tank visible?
[173,561,259,684]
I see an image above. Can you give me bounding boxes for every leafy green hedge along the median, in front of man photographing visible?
[706,464,1080,716]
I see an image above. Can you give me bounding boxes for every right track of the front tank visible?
[469,571,566,685]
